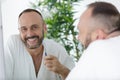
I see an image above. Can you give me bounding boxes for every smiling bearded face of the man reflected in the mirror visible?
[19,12,45,49]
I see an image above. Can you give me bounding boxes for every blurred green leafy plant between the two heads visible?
[31,0,82,61]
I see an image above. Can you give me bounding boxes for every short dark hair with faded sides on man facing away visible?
[88,2,120,33]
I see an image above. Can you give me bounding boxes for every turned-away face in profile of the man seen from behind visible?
[78,9,92,48]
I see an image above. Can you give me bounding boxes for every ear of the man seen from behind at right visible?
[91,29,107,40]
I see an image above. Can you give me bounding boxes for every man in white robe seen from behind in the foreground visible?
[66,2,120,80]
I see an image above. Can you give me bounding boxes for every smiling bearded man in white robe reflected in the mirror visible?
[5,9,74,80]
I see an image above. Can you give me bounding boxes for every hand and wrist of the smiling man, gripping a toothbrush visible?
[44,55,70,79]
